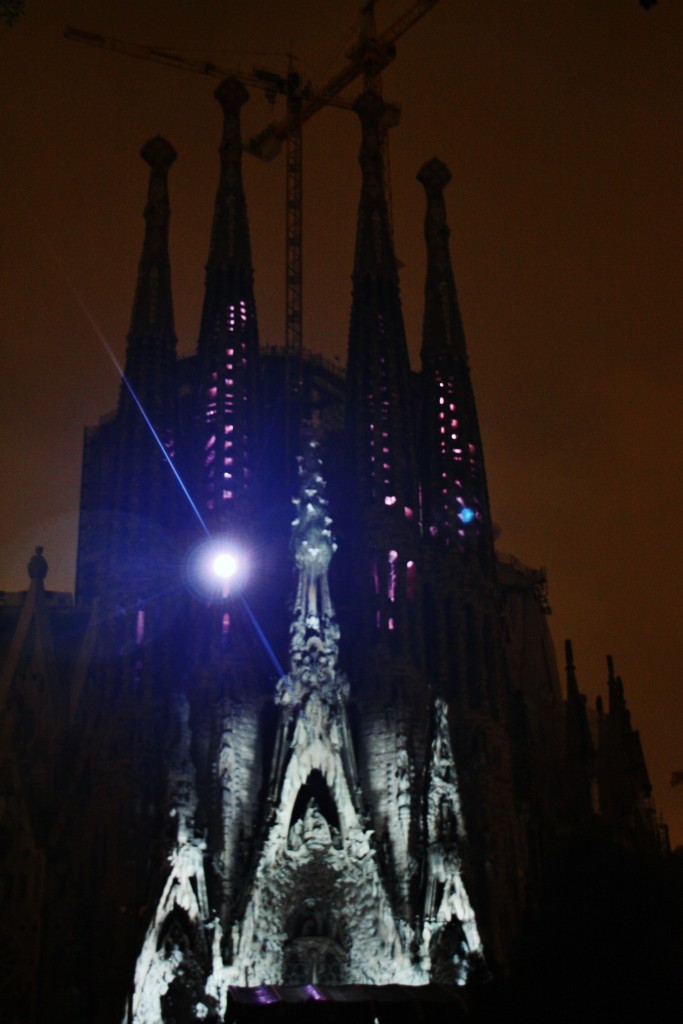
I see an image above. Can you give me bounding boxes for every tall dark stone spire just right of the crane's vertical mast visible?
[345,91,418,659]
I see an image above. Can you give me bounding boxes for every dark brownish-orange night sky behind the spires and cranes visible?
[0,0,683,843]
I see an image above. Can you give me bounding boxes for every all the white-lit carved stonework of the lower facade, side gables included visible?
[125,444,482,1024]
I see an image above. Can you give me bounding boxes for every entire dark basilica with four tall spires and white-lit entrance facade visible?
[0,80,666,1024]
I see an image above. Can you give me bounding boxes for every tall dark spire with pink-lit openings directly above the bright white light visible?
[198,78,258,528]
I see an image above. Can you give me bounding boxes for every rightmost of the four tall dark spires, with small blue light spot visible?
[418,159,494,572]
